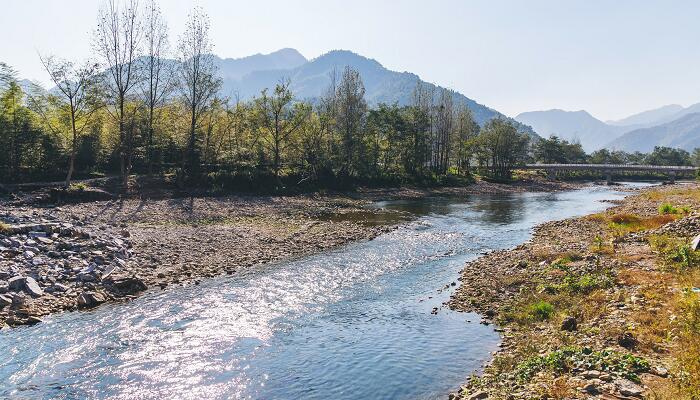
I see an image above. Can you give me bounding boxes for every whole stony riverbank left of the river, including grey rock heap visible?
[0,196,400,326]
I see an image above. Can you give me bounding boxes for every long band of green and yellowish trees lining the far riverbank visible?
[0,0,698,190]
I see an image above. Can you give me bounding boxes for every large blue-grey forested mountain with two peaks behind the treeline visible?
[220,49,534,134]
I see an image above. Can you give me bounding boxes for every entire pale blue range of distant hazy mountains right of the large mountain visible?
[515,103,700,152]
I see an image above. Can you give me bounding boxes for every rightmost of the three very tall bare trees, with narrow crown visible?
[178,8,221,177]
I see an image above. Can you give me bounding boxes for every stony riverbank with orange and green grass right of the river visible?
[449,184,700,399]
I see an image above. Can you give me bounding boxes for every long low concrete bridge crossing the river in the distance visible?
[522,164,698,184]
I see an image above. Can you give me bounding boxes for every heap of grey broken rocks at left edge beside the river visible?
[0,214,146,326]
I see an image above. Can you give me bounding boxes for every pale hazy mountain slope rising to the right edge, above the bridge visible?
[606,112,700,152]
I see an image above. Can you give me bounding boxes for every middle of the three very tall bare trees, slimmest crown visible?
[141,0,173,175]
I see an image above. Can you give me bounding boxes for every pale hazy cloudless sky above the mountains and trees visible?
[0,0,700,120]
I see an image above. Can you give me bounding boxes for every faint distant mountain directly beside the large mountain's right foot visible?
[515,109,626,152]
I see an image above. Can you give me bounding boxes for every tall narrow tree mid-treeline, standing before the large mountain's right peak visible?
[335,66,367,177]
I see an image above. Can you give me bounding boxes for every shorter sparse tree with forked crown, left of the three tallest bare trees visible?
[35,57,100,187]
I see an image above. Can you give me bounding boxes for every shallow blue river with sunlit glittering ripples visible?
[0,187,636,399]
